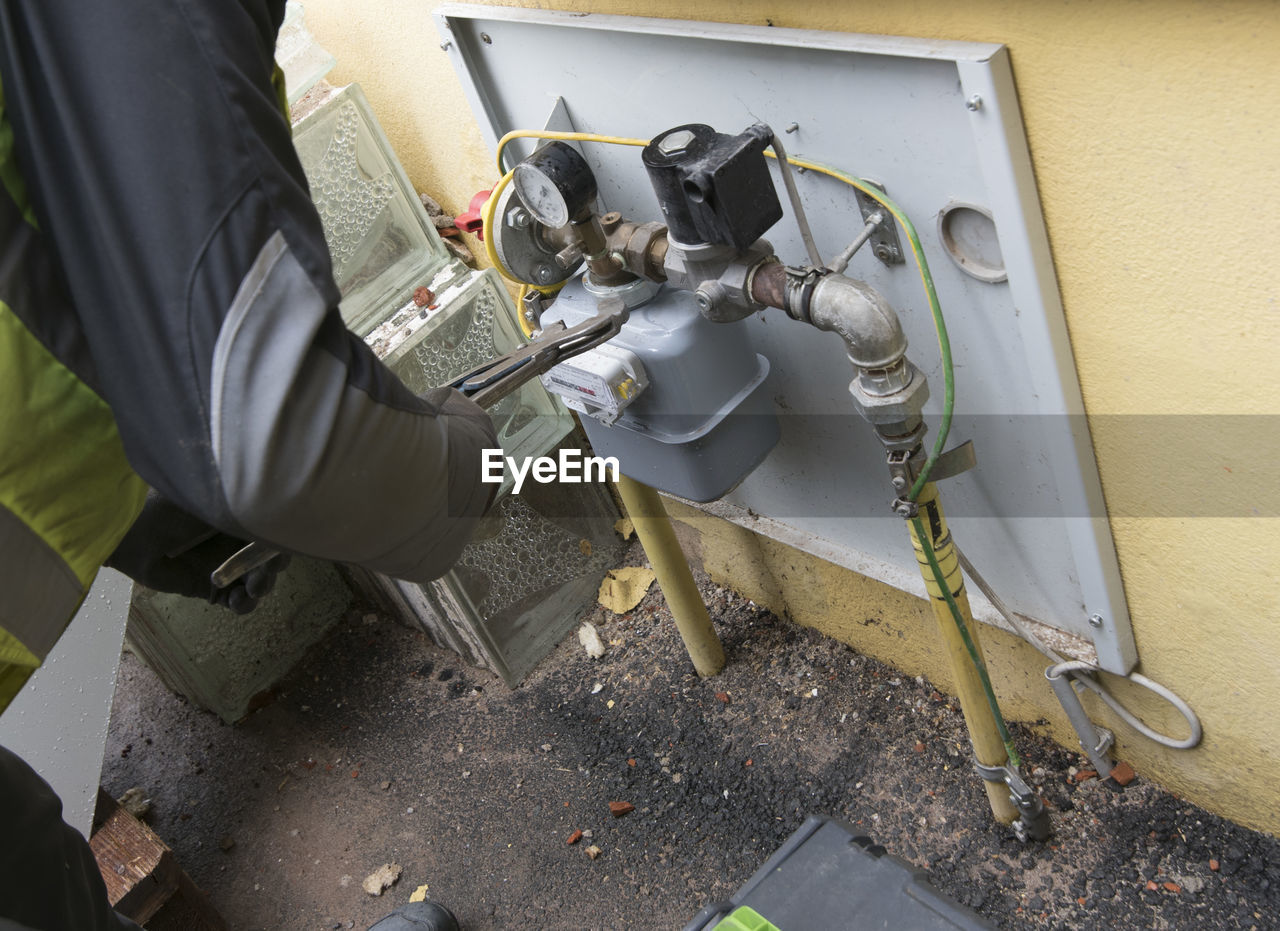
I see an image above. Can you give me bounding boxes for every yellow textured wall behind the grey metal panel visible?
[305,0,1280,831]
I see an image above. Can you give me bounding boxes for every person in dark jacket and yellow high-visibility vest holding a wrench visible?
[0,0,497,931]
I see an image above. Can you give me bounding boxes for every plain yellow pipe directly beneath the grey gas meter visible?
[617,475,724,676]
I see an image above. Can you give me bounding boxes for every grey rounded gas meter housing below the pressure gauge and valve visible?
[543,275,780,501]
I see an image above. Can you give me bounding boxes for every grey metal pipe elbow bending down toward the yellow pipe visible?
[809,275,906,369]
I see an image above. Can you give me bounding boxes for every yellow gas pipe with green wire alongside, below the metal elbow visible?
[908,482,1020,825]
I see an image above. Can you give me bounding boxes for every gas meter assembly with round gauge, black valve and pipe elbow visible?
[492,123,928,501]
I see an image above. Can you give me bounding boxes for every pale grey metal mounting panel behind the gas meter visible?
[436,4,1137,672]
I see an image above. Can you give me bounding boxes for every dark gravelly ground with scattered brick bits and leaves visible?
[104,547,1280,931]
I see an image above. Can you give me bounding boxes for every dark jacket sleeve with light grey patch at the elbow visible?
[0,0,497,580]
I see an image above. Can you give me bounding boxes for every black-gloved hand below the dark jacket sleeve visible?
[106,490,289,615]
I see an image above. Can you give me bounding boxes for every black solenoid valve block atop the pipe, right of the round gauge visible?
[641,123,782,248]
